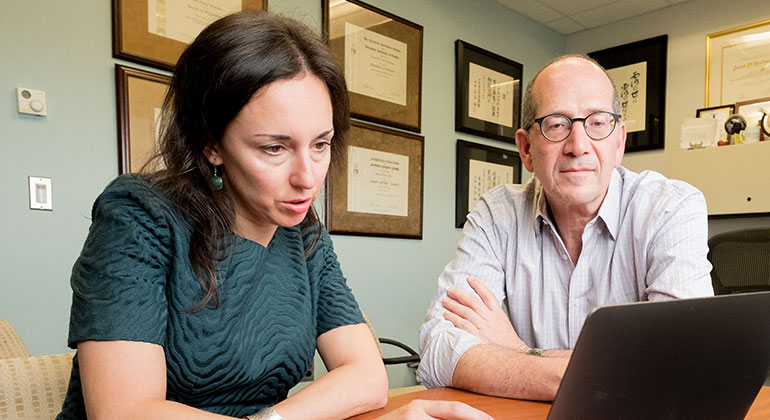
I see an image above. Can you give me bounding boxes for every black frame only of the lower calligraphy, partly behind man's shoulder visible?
[455,140,521,228]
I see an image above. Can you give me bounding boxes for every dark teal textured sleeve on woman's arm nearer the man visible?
[303,226,364,336]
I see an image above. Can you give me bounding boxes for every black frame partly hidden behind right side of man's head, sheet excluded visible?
[588,35,668,153]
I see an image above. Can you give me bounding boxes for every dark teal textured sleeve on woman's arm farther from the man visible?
[68,175,171,348]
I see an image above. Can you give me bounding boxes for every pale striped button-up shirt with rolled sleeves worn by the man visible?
[417,167,714,387]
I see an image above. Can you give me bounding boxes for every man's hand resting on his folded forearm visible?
[442,277,528,351]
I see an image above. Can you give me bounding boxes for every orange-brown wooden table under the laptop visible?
[350,386,770,420]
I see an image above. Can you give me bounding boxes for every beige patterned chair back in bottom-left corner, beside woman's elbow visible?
[0,353,75,420]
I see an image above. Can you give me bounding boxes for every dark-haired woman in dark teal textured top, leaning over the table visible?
[57,11,488,420]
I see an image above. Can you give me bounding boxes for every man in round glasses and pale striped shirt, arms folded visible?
[417,56,713,400]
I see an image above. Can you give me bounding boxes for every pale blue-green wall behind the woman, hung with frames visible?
[0,0,564,385]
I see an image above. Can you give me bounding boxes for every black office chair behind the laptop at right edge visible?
[708,228,770,295]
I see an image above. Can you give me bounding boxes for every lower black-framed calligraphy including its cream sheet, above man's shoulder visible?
[455,140,521,228]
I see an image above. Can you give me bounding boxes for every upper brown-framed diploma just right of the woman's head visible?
[323,0,422,133]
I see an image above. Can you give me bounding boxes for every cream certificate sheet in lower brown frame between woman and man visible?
[347,146,409,216]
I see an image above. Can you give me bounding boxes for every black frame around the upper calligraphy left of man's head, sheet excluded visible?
[455,39,524,144]
